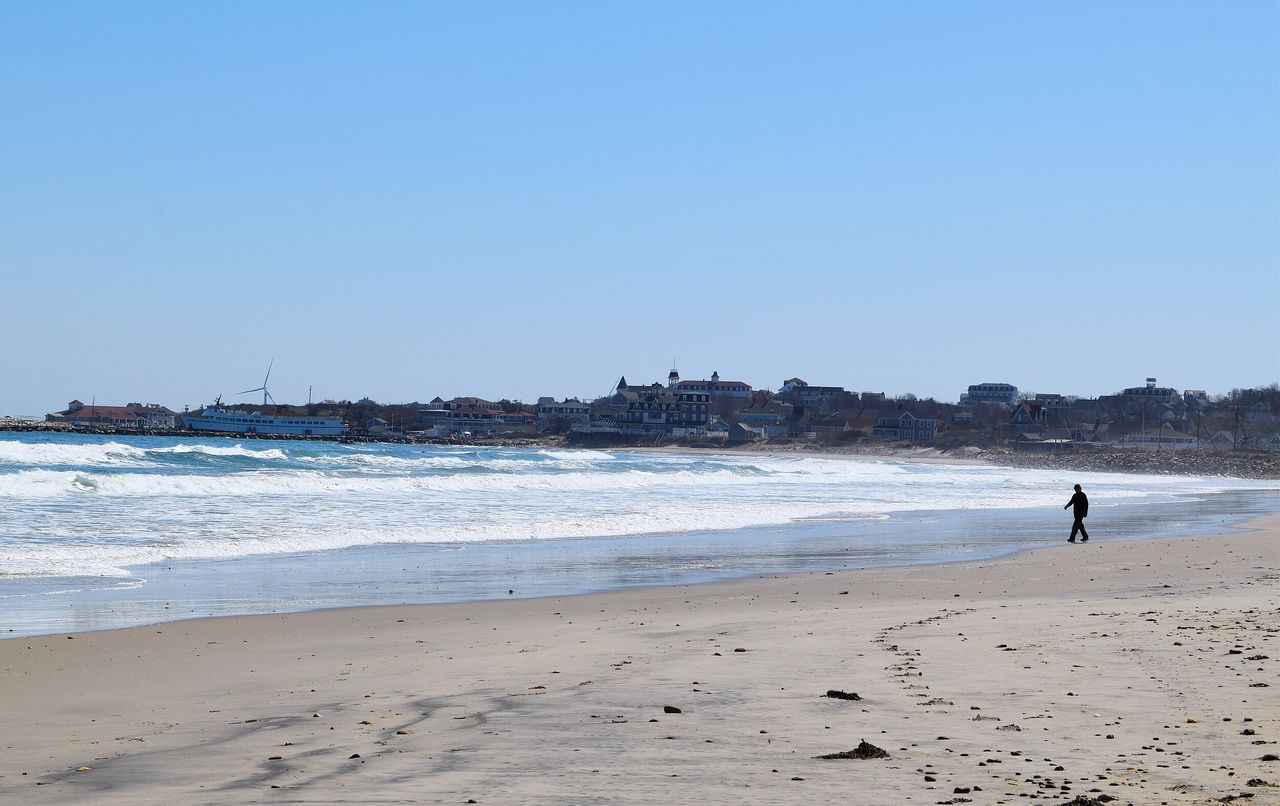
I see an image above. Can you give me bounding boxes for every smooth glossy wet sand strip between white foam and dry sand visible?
[0,490,1280,642]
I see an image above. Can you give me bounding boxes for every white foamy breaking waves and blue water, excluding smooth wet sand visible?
[0,438,1275,577]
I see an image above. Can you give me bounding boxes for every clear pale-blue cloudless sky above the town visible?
[0,0,1280,415]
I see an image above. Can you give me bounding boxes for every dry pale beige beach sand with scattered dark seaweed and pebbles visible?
[0,517,1280,803]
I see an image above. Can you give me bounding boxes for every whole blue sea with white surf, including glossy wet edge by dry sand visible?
[0,434,1277,635]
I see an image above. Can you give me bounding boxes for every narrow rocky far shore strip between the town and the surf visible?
[0,422,1280,480]
